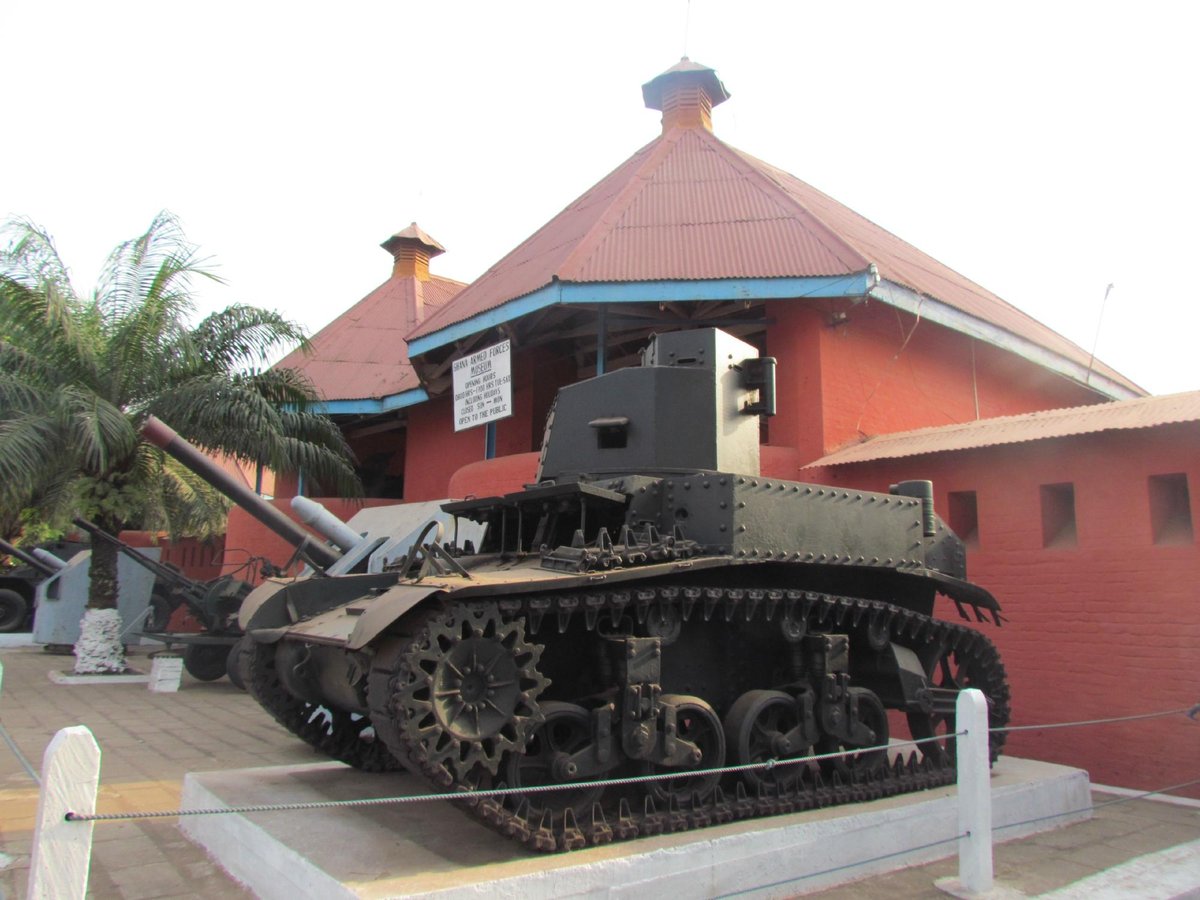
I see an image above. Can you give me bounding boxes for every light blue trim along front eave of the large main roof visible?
[408,270,876,359]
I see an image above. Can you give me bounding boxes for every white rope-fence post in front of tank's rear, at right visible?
[955,688,992,895]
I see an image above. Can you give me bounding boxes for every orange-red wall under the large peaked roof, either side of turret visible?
[424,300,1113,499]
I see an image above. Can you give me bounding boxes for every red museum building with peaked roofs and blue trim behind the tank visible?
[229,59,1200,801]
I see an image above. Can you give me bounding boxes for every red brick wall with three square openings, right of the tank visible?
[805,424,1200,797]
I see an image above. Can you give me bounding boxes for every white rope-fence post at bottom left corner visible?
[26,725,100,900]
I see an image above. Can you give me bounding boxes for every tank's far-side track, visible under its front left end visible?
[236,636,400,772]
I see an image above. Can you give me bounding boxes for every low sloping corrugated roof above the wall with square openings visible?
[803,391,1200,469]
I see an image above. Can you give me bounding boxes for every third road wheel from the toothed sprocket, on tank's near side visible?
[725,690,809,790]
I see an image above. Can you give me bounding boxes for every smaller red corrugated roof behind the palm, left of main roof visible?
[276,277,464,401]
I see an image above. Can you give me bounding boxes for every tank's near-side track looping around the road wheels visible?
[367,587,1009,852]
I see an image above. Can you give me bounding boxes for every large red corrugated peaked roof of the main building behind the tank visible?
[408,65,1142,394]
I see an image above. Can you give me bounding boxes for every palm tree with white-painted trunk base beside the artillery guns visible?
[0,212,361,672]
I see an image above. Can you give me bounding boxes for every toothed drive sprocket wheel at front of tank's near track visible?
[395,604,550,781]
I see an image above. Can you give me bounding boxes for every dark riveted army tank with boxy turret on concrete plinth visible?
[229,329,1009,851]
